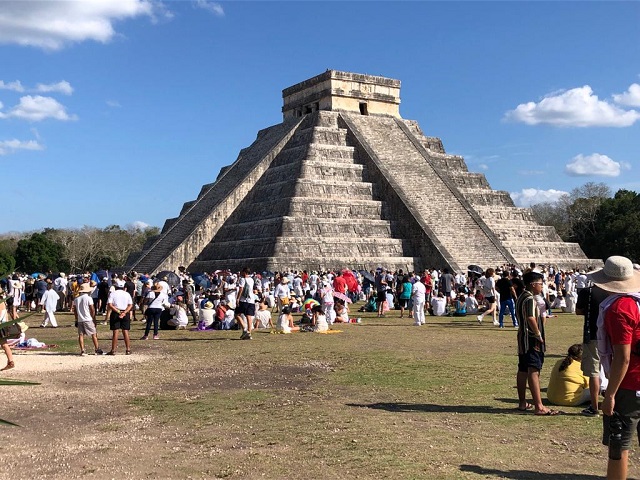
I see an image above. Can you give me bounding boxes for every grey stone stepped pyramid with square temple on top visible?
[127,70,592,273]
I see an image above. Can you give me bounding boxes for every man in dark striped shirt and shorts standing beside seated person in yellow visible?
[516,271,558,415]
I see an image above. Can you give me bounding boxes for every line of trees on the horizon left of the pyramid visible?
[0,225,159,276]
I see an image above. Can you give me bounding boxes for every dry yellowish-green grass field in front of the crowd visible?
[1,308,640,480]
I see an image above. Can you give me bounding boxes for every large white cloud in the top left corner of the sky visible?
[0,0,159,50]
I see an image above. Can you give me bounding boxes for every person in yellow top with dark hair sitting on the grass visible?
[547,343,590,407]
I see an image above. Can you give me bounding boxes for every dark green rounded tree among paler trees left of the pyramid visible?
[15,230,68,272]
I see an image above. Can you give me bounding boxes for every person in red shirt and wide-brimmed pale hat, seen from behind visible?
[588,256,640,479]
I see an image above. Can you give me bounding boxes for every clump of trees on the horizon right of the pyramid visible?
[531,182,640,262]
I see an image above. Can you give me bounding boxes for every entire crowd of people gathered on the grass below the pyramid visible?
[0,256,640,478]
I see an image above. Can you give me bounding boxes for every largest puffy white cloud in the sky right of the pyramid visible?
[505,85,640,127]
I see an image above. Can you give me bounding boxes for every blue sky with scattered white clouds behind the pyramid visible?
[0,0,640,232]
